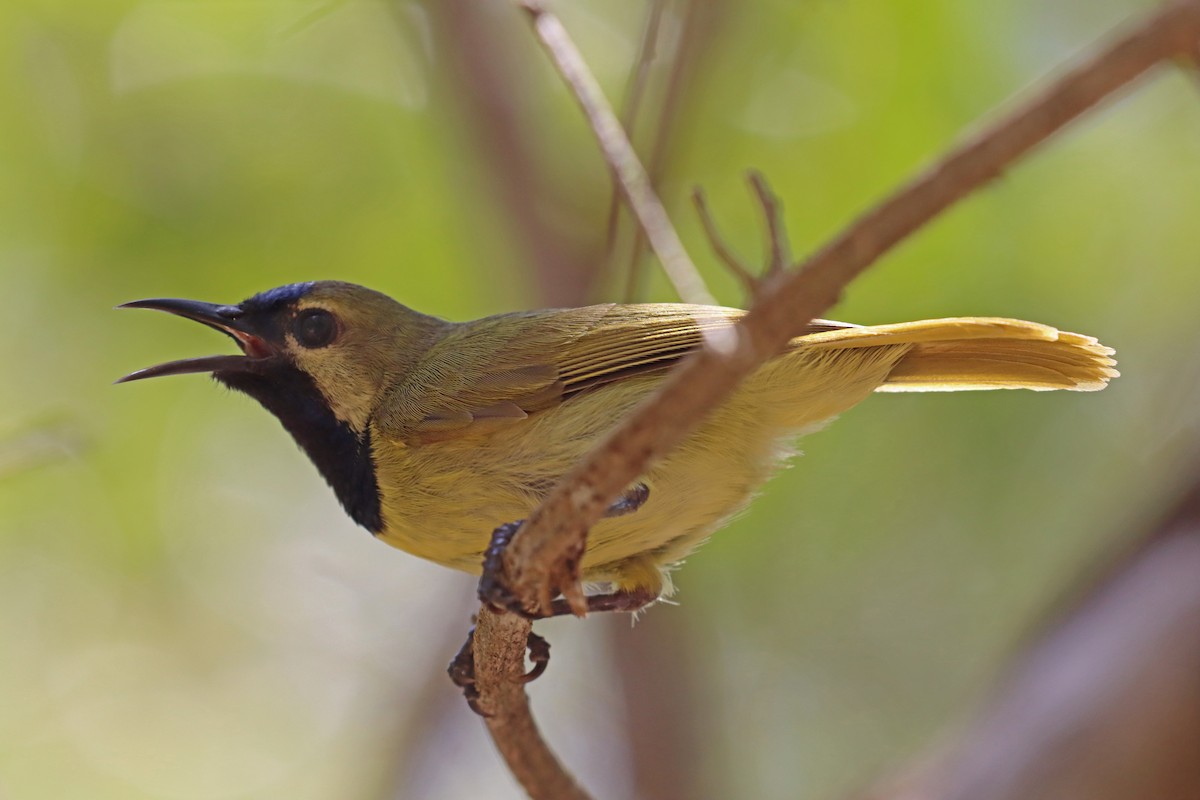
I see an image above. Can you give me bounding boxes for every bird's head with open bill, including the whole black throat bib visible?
[118,281,450,534]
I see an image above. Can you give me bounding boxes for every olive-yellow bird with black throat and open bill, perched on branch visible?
[118,281,1118,606]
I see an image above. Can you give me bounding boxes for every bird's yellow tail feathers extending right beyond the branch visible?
[794,317,1120,392]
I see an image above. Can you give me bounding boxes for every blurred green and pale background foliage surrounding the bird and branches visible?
[0,0,1200,800]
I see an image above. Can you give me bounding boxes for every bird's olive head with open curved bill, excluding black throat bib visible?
[119,281,446,432]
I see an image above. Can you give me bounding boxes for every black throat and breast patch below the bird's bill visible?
[212,362,383,534]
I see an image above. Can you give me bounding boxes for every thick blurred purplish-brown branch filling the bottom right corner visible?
[869,474,1200,800]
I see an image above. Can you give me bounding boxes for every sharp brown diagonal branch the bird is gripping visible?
[463,0,1200,798]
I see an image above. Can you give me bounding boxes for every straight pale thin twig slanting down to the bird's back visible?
[518,0,715,305]
